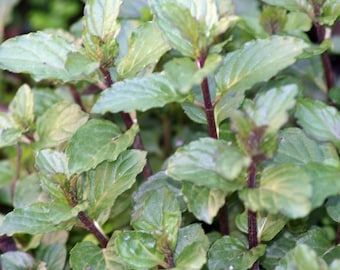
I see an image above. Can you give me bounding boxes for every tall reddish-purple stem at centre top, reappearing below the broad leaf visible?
[196,52,229,235]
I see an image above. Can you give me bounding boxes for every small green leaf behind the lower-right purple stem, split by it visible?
[236,211,288,242]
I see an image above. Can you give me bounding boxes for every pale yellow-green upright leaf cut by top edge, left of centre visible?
[84,0,122,40]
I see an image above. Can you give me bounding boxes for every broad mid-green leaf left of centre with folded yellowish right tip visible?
[66,119,138,174]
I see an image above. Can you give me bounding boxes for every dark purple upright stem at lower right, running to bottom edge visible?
[248,161,260,270]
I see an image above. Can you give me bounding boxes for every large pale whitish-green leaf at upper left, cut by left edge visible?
[0,32,76,82]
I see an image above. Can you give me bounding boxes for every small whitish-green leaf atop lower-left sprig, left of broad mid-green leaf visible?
[35,149,70,177]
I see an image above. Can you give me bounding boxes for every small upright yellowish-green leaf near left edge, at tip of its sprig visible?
[9,84,34,131]
